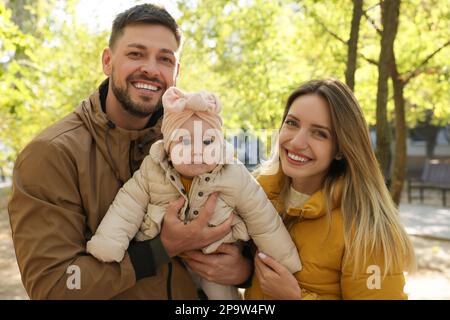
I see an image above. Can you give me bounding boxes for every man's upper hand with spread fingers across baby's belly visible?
[161,193,233,257]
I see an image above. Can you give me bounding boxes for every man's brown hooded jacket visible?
[8,80,197,299]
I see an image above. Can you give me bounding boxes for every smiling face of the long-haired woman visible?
[279,94,336,194]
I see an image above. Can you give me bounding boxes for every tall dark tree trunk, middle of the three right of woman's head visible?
[376,0,400,181]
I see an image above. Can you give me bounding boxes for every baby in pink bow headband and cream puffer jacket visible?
[87,87,301,300]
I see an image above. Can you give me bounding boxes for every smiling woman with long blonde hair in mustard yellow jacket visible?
[246,79,415,299]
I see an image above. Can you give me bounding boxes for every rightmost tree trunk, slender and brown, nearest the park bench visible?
[391,51,407,206]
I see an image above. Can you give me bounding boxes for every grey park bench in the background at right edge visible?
[408,160,450,207]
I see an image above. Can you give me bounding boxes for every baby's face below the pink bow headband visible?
[169,115,222,178]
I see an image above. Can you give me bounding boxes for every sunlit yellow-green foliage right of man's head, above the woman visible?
[179,0,450,128]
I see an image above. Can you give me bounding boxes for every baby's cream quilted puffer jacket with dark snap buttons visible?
[87,140,301,273]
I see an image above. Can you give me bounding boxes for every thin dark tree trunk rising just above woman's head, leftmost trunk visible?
[345,0,363,91]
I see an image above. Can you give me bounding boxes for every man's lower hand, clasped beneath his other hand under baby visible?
[182,243,252,285]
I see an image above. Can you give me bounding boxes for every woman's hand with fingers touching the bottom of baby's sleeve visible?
[255,252,302,300]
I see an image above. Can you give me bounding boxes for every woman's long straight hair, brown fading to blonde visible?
[259,79,415,275]
